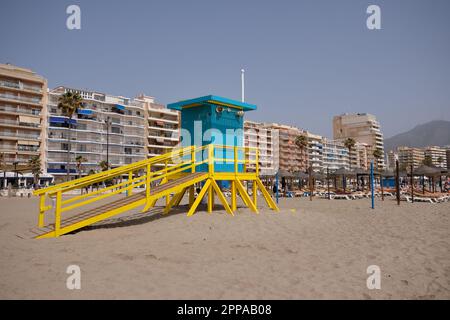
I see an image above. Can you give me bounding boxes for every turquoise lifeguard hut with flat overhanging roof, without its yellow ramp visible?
[167,95,256,172]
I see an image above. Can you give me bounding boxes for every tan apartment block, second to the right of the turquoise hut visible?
[266,123,309,172]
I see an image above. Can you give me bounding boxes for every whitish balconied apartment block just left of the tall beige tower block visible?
[322,139,350,172]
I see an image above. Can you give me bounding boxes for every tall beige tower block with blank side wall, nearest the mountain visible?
[333,113,385,170]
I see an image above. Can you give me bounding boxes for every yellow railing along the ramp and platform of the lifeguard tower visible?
[33,144,259,234]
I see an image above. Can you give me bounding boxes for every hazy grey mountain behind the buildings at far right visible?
[384,120,450,152]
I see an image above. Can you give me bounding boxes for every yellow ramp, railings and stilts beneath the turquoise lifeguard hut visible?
[30,144,278,238]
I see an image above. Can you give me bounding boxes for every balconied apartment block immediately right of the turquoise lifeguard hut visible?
[244,120,280,176]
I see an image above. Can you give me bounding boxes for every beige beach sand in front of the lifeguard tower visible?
[0,198,450,299]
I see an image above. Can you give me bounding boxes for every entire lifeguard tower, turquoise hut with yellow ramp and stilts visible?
[30,95,279,238]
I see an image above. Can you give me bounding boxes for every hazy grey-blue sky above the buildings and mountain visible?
[0,0,450,137]
